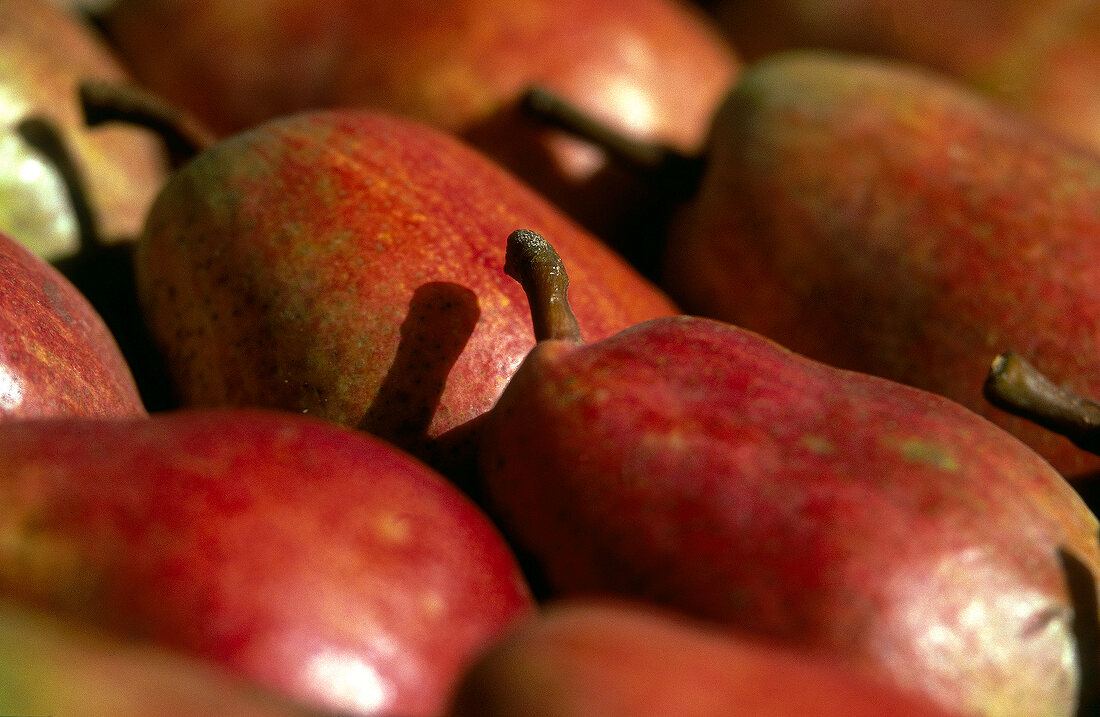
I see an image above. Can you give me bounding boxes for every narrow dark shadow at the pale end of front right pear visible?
[1058,548,1100,717]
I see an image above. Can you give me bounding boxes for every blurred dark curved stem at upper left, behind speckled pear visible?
[78,80,217,167]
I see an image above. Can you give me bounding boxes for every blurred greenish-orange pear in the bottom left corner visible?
[0,600,319,717]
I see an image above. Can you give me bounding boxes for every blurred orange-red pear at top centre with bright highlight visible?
[96,0,738,236]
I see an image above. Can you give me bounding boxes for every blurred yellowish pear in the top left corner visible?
[0,0,165,260]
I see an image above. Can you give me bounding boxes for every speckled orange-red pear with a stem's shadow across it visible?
[136,110,678,475]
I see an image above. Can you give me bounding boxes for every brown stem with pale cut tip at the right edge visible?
[982,352,1100,455]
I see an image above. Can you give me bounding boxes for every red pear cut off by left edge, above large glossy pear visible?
[0,233,145,423]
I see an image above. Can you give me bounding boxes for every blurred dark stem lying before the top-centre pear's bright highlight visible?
[519,86,705,197]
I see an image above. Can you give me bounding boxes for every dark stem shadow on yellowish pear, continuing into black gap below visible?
[17,117,178,411]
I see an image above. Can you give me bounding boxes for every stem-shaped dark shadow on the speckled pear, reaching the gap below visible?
[359,282,481,492]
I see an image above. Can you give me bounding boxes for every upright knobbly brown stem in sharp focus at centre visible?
[504,229,581,343]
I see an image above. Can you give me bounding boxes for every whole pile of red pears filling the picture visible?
[0,0,1100,717]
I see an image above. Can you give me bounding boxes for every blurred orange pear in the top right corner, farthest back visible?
[713,0,1100,156]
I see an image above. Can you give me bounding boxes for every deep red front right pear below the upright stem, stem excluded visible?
[482,317,1100,717]
